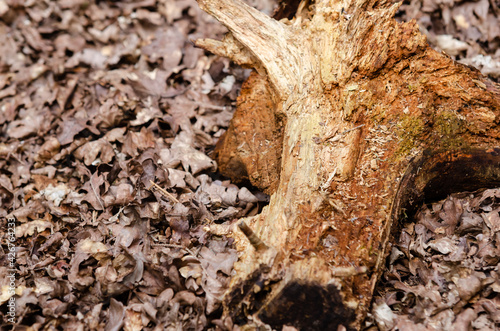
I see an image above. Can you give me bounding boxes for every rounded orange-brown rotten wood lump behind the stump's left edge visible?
[215,73,283,193]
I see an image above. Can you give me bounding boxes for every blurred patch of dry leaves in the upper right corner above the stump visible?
[398,0,500,82]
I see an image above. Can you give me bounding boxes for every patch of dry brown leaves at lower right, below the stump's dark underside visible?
[372,189,500,330]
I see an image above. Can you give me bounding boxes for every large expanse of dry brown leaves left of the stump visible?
[0,0,274,330]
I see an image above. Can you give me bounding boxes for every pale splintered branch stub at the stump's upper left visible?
[196,0,300,99]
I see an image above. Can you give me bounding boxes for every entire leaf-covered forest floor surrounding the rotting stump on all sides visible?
[0,0,500,330]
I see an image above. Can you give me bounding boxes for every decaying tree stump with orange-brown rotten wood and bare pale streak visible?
[197,0,500,330]
